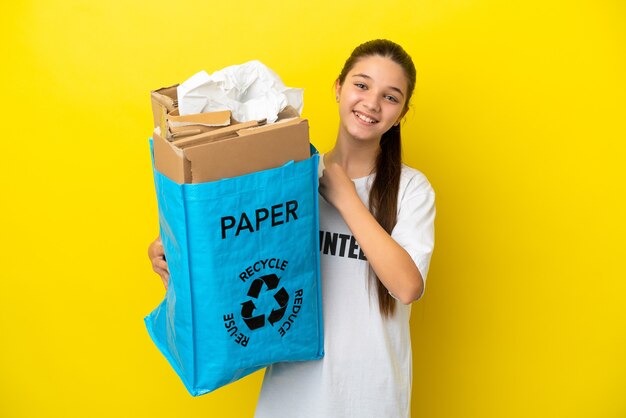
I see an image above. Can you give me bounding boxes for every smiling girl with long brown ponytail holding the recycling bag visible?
[149,40,435,418]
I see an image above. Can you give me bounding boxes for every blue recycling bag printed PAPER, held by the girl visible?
[145,143,324,396]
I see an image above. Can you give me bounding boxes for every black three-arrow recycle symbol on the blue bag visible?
[241,274,289,331]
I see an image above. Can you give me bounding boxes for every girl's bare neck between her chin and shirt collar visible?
[325,131,380,179]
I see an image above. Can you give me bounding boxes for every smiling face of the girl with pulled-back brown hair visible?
[335,55,408,142]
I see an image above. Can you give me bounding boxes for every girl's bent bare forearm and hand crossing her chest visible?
[320,163,424,304]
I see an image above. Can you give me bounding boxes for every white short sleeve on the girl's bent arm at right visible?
[391,167,435,292]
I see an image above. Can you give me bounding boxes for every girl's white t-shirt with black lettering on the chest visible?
[255,158,435,418]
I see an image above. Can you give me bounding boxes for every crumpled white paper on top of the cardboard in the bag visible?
[178,60,304,123]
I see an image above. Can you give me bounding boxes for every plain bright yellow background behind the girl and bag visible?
[0,0,626,418]
